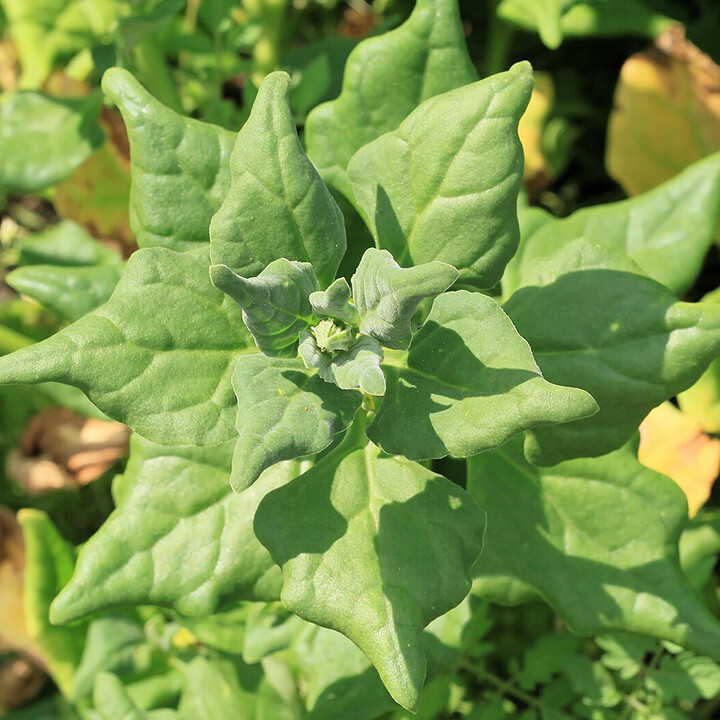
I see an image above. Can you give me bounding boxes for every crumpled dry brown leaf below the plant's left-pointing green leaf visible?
[8,408,130,495]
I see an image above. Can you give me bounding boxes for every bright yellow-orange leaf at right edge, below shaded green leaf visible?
[638,402,720,517]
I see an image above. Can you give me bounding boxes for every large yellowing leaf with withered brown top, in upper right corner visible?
[606,26,720,195]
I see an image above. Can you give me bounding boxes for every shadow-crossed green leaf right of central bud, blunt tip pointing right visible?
[368,290,597,460]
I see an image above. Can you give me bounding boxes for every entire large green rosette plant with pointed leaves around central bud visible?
[0,0,720,709]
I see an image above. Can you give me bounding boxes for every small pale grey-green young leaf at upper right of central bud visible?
[352,248,458,350]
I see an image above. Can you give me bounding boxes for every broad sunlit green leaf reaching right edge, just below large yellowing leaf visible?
[502,154,720,297]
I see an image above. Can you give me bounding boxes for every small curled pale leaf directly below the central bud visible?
[298,332,385,395]
